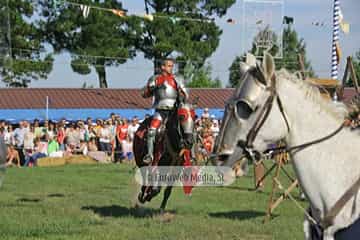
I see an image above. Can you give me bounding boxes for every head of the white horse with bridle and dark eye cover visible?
[215,54,289,166]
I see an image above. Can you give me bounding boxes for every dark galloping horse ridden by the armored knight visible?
[133,103,195,212]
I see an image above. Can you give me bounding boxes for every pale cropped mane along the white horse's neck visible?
[276,69,348,121]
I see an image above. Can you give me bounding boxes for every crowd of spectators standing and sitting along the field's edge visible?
[0,108,219,167]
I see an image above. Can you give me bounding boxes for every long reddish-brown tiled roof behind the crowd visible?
[0,88,234,109]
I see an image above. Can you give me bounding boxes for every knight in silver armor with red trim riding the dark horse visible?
[142,59,189,164]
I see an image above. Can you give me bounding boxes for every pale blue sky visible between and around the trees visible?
[29,0,360,88]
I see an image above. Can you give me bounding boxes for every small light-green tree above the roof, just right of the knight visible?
[184,62,221,88]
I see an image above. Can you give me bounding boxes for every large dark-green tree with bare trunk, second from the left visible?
[40,0,136,88]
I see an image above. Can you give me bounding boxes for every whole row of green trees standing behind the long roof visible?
[0,0,360,88]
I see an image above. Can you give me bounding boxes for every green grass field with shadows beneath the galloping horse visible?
[0,162,306,240]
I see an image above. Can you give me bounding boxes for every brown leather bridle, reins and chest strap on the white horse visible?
[237,74,360,229]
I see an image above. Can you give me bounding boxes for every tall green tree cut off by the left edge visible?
[0,0,53,87]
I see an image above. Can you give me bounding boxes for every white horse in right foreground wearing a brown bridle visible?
[215,54,360,240]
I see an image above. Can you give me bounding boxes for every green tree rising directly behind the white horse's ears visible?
[229,21,315,87]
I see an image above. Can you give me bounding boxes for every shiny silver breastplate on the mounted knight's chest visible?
[153,81,178,109]
